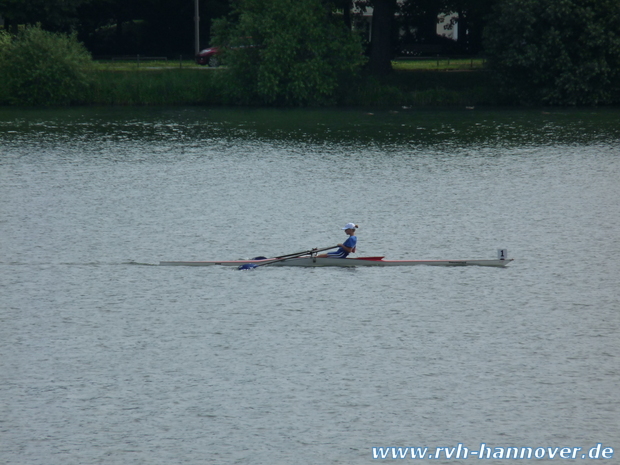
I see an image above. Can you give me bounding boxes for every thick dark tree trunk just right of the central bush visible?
[368,0,396,75]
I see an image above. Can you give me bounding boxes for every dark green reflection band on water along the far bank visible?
[0,108,620,148]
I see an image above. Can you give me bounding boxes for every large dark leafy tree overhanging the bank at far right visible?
[485,0,620,105]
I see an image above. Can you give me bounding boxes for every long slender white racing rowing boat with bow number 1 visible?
[159,256,514,267]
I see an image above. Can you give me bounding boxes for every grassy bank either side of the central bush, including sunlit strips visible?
[0,58,497,106]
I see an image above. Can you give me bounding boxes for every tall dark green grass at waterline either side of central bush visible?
[85,69,497,106]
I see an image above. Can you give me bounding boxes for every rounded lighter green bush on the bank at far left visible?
[0,26,92,105]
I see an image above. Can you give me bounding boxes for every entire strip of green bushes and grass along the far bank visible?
[0,0,620,106]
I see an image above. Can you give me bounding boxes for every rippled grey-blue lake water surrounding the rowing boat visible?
[0,108,620,465]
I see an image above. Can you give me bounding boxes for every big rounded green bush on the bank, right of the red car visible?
[214,0,363,105]
